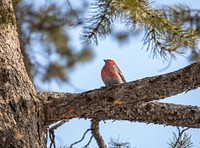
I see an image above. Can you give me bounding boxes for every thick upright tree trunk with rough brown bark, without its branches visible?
[0,0,45,148]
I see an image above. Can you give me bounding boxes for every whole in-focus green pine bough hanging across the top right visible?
[83,0,199,57]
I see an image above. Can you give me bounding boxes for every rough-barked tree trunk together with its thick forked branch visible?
[0,0,200,148]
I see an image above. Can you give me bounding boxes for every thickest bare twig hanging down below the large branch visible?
[91,119,106,148]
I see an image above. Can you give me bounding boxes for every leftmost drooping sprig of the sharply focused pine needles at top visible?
[83,0,115,44]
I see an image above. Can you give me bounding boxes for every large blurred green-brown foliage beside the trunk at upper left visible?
[15,1,93,86]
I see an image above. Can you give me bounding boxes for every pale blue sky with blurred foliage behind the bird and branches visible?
[15,0,200,148]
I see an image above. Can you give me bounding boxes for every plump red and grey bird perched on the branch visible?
[101,59,126,86]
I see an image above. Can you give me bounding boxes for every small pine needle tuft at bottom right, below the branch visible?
[168,127,193,148]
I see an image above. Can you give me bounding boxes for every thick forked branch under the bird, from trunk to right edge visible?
[39,63,200,127]
